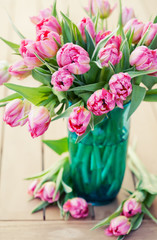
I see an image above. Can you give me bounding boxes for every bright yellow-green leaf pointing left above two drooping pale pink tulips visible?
[4,83,52,105]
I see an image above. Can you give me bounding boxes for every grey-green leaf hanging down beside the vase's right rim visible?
[128,85,146,119]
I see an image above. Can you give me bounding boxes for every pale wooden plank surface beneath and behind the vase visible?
[0,0,157,240]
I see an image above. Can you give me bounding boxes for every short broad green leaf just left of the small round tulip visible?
[32,67,52,86]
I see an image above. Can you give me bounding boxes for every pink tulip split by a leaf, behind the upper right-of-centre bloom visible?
[95,31,122,51]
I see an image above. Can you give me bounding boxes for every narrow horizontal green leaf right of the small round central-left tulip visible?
[68,82,104,92]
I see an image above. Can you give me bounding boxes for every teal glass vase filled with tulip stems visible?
[68,103,130,205]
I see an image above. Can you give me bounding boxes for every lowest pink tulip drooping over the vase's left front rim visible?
[68,107,91,136]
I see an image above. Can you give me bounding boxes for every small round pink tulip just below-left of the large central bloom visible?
[51,68,74,91]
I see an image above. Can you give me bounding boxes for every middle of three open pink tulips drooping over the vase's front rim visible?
[87,88,115,116]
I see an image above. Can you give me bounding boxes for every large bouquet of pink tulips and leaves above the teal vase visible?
[0,0,157,141]
